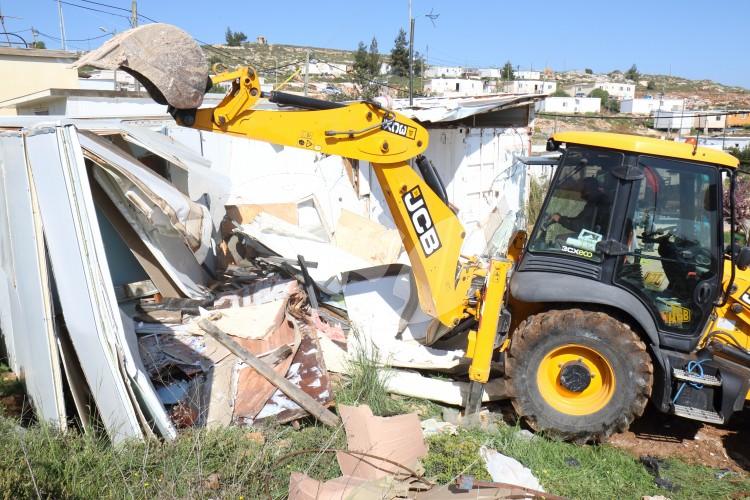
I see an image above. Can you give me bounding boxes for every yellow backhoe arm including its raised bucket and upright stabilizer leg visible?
[76,23,511,411]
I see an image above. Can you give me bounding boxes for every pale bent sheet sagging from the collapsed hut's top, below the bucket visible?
[122,123,232,227]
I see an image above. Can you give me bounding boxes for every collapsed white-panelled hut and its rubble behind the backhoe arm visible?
[0,91,534,442]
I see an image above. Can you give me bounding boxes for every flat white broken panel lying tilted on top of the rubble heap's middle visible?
[237,212,371,292]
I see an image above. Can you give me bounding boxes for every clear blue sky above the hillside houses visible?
[5,0,750,88]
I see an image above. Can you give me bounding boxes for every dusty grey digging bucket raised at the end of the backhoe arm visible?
[73,23,210,109]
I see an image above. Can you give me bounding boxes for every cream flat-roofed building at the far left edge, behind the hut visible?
[0,47,78,114]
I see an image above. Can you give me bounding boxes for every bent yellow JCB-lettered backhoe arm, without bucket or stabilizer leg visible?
[174,63,477,327]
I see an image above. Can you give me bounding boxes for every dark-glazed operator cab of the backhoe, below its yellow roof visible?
[519,134,723,350]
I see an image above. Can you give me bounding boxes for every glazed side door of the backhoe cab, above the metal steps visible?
[613,156,722,350]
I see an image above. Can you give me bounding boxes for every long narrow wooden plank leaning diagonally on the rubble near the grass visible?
[198,319,341,427]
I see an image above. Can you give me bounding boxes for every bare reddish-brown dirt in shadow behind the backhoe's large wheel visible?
[609,406,750,472]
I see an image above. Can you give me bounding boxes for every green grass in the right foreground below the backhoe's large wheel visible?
[425,425,750,500]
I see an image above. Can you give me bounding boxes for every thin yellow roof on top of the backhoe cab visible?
[552,132,740,168]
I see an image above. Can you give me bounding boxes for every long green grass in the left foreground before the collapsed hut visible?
[0,419,345,499]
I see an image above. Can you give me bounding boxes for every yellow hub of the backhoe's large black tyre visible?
[536,344,615,415]
